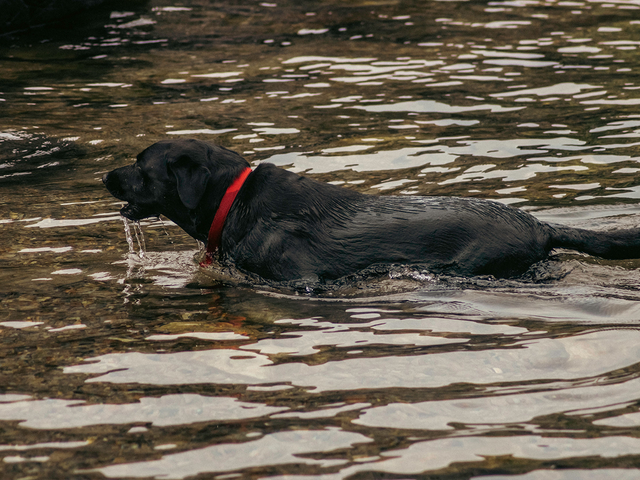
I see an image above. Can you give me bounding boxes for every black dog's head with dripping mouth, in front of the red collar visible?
[102,139,249,241]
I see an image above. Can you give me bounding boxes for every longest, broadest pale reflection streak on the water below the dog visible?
[64,325,640,394]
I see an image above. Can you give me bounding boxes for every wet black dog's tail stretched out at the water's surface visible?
[549,225,640,259]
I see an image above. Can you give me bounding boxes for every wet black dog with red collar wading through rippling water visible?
[103,139,640,281]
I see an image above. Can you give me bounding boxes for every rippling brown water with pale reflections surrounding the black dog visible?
[0,0,640,480]
